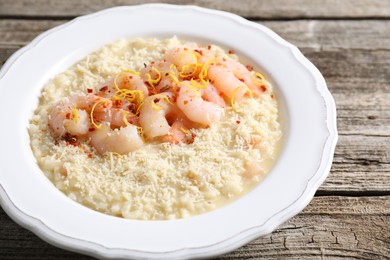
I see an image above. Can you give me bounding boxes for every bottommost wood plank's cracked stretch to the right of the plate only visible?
[220,197,390,259]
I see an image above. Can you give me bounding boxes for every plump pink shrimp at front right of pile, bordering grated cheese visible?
[176,81,223,126]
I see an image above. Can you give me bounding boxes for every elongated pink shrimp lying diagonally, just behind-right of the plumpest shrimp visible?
[207,64,248,101]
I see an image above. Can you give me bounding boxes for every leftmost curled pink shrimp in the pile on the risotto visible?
[49,94,112,137]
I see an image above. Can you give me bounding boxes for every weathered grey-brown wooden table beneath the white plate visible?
[0,0,390,259]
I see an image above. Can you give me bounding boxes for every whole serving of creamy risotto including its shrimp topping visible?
[29,37,282,220]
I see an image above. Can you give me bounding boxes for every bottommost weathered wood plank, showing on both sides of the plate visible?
[0,196,390,260]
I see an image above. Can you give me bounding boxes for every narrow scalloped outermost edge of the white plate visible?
[0,4,338,258]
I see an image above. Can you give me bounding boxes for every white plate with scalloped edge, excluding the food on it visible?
[0,4,337,259]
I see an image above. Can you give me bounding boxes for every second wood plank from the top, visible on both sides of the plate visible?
[0,19,390,50]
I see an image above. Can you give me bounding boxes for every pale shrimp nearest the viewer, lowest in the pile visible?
[90,124,144,154]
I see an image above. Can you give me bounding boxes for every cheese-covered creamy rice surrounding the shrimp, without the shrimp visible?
[29,37,282,220]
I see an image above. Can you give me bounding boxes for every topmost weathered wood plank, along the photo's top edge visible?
[0,0,390,19]
